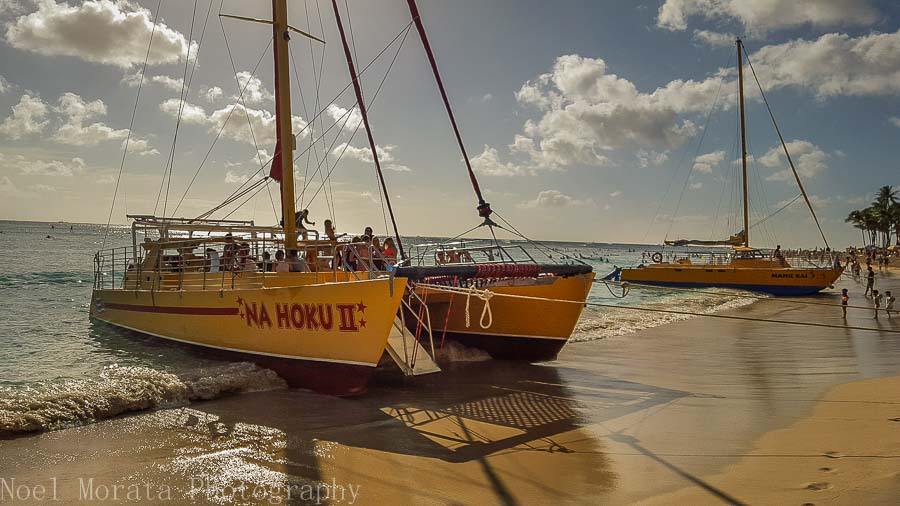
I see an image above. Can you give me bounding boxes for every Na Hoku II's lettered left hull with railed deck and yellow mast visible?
[90,0,434,395]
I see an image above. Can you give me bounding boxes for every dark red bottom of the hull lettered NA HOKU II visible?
[91,316,375,397]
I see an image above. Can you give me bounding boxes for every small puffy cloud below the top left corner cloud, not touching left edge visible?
[53,93,128,146]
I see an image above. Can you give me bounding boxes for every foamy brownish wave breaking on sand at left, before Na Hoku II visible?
[0,362,287,437]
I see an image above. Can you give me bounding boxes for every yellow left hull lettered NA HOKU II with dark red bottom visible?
[91,279,406,395]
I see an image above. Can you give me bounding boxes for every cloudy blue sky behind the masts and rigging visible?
[0,0,900,246]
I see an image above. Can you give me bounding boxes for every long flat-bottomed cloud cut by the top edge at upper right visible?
[656,0,879,36]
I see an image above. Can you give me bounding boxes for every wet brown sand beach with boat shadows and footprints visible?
[0,268,900,504]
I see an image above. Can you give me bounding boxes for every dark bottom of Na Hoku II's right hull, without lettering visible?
[435,331,567,362]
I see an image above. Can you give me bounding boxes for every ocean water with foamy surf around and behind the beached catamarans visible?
[0,221,753,436]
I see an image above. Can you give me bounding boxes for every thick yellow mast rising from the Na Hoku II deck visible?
[272,0,297,250]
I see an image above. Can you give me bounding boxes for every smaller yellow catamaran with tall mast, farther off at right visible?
[615,39,843,295]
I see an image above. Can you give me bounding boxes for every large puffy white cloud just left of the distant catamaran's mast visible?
[516,54,712,167]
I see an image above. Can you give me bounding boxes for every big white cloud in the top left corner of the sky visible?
[6,0,196,68]
